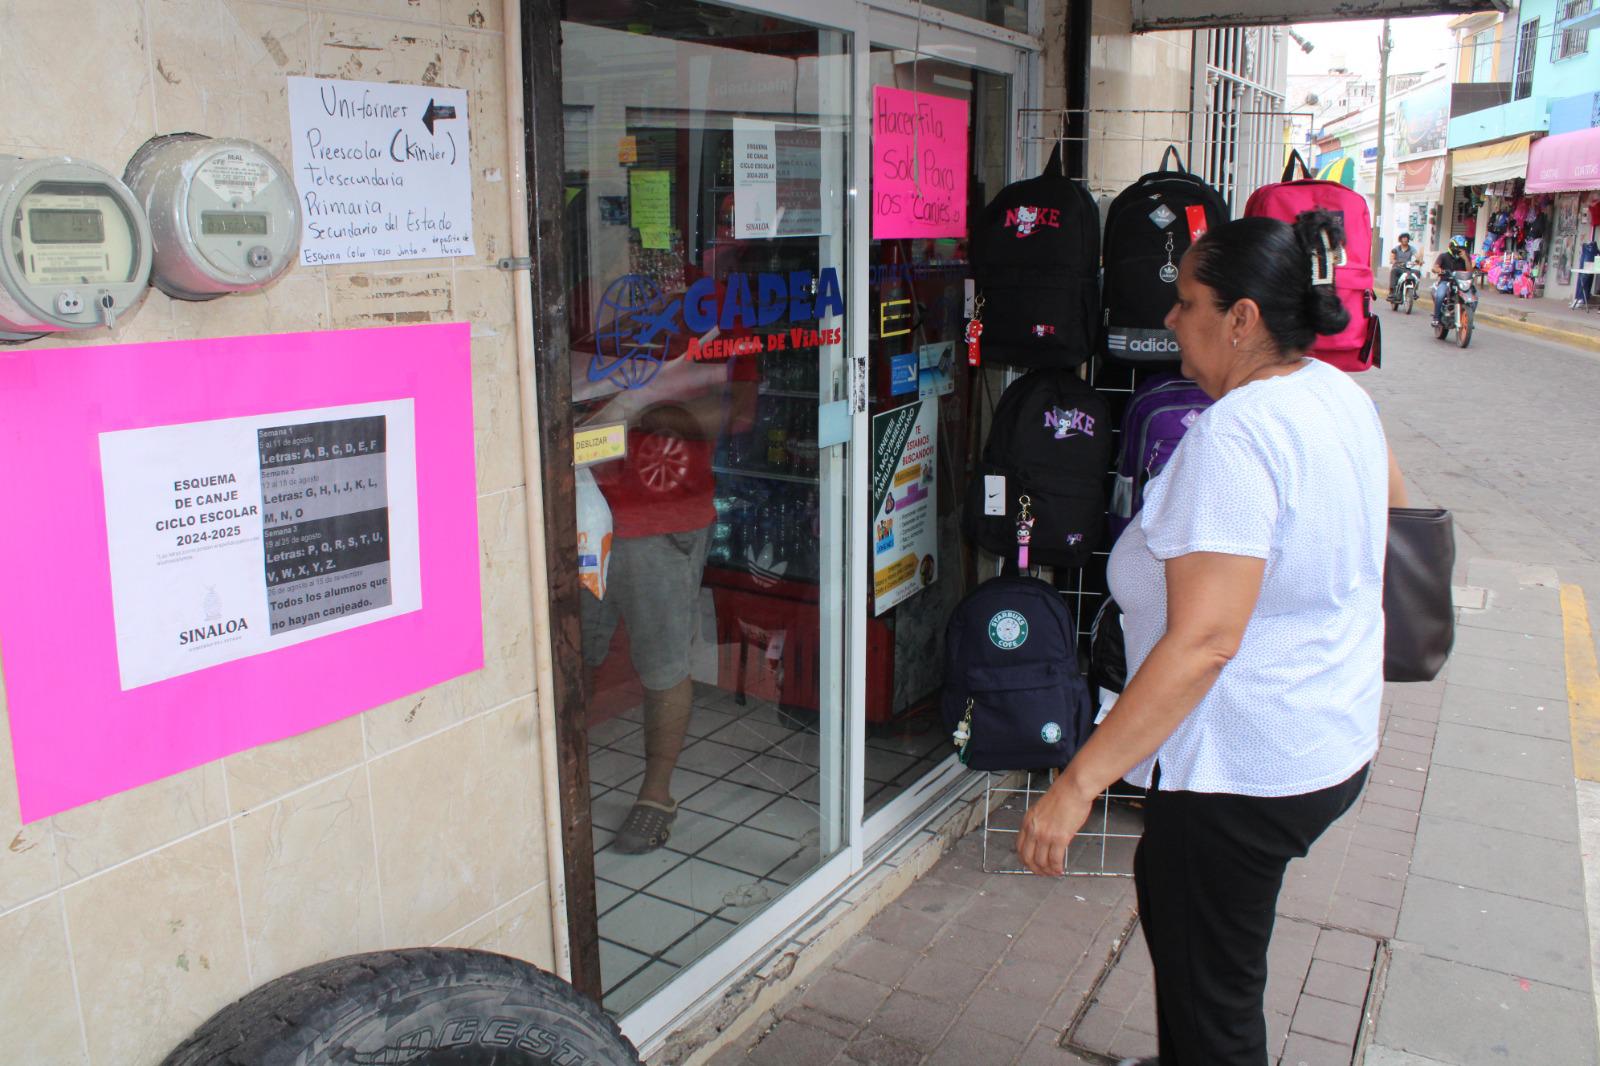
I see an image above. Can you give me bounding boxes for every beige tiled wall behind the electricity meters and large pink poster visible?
[0,0,550,1066]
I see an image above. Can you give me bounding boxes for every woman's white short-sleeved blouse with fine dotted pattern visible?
[1107,360,1389,795]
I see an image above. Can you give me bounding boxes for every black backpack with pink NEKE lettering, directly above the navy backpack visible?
[963,370,1112,570]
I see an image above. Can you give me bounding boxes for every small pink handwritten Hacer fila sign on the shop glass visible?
[872,85,968,240]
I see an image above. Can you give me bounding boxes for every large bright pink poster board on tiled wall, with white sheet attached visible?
[0,323,483,821]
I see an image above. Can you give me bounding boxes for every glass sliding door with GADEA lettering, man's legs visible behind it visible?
[562,0,851,1015]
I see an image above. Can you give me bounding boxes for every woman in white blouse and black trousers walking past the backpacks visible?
[1018,211,1400,1066]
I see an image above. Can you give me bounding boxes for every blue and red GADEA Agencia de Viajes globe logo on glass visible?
[589,267,845,389]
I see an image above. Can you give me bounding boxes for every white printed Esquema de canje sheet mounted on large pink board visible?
[99,400,422,690]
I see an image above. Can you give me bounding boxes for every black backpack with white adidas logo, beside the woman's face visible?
[1101,144,1227,363]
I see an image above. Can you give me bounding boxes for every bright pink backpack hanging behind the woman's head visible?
[1245,152,1382,375]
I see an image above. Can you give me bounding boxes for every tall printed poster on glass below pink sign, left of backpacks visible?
[872,400,939,615]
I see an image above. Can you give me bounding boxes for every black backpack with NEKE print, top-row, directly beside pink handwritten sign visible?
[971,146,1099,367]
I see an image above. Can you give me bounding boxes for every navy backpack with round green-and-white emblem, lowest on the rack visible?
[941,578,1094,770]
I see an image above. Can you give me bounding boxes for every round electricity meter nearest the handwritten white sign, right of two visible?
[123,133,301,299]
